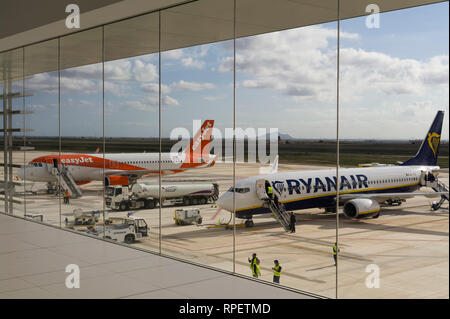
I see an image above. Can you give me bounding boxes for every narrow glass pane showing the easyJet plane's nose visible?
[19,40,60,226]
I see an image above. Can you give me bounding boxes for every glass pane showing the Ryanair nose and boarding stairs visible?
[232,1,337,297]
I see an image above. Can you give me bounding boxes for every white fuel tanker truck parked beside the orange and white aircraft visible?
[105,182,219,211]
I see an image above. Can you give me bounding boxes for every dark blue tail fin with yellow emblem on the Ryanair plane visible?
[402,111,444,166]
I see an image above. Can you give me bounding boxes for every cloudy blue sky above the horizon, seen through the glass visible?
[15,2,449,140]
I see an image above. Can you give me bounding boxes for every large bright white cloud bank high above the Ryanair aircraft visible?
[218,26,449,102]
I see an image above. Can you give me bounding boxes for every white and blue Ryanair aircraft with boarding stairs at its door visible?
[217,111,448,226]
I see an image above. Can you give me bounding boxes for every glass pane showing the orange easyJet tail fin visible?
[161,1,233,271]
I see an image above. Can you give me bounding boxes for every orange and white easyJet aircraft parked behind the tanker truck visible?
[17,120,217,186]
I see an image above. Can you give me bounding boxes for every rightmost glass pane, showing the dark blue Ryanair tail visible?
[338,2,449,298]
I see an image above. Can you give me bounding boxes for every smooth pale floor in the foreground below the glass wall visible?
[0,214,312,299]
